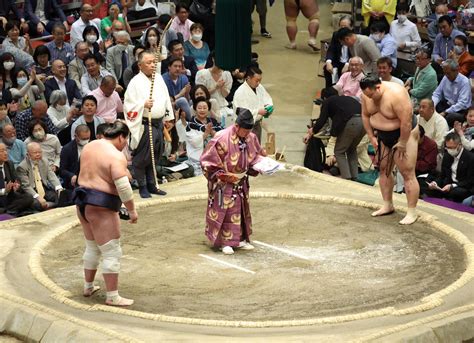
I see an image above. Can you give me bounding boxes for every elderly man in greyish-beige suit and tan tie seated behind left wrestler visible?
[16,142,63,211]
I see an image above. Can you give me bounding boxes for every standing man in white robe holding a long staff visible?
[124,52,174,198]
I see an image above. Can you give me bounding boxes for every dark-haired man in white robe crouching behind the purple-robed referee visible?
[232,66,273,142]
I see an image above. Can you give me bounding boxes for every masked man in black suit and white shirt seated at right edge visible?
[427,132,474,202]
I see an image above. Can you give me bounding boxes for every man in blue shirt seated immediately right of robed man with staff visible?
[163,58,192,121]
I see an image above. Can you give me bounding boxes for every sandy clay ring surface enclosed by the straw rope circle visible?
[42,198,466,321]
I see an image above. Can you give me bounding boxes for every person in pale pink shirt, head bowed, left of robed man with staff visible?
[89,75,123,123]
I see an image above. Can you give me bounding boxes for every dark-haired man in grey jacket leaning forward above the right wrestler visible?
[337,27,380,74]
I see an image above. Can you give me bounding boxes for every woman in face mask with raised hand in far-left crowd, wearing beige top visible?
[10,68,45,111]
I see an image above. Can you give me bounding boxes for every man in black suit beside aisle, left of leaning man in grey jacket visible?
[323,15,354,88]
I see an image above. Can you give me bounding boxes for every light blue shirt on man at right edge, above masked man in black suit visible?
[432,73,472,113]
